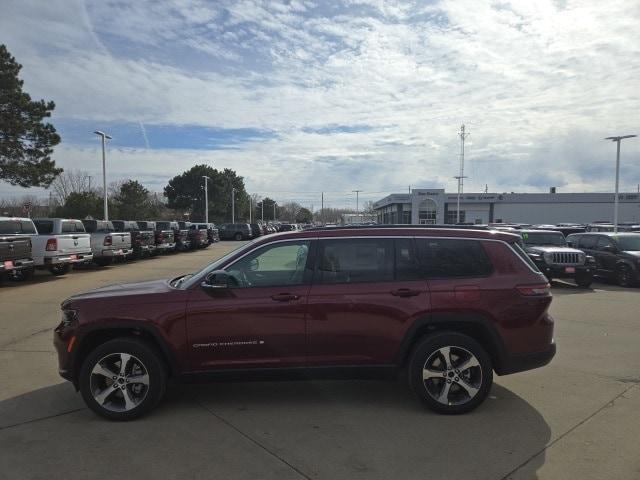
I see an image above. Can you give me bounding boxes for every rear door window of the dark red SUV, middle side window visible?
[316,238,394,284]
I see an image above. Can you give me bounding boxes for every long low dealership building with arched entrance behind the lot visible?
[373,189,640,225]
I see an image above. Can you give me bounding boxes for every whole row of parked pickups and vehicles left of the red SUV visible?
[0,217,219,280]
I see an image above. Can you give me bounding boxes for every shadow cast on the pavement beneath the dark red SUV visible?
[0,380,551,480]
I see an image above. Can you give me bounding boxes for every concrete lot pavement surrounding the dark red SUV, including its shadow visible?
[0,242,640,480]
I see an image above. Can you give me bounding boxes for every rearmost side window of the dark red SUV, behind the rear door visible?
[416,238,493,278]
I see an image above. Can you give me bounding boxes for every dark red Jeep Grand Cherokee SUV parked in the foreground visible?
[54,227,555,419]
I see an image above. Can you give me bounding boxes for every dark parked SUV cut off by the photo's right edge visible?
[567,232,640,287]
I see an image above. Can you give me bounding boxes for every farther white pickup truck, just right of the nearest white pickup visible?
[82,220,133,267]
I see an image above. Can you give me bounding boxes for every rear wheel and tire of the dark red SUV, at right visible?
[409,332,493,415]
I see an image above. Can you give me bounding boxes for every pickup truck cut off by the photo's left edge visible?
[0,217,37,282]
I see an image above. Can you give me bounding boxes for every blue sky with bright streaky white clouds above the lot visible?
[0,0,640,208]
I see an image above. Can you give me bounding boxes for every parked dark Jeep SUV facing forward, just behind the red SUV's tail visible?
[517,230,595,288]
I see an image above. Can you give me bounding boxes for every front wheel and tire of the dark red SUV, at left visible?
[79,338,166,420]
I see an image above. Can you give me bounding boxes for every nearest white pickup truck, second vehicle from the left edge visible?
[31,218,93,275]
